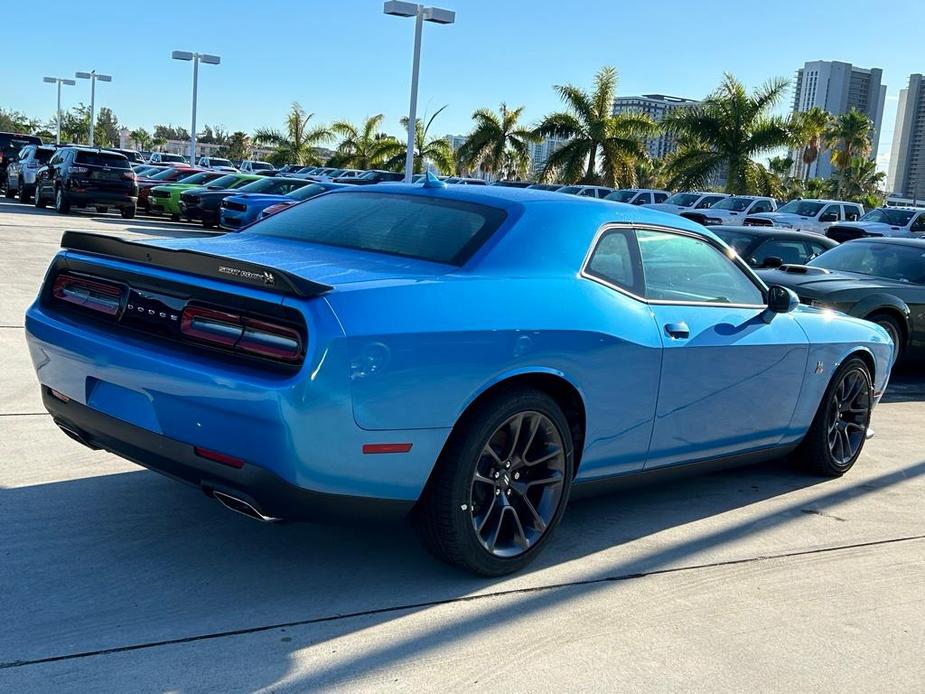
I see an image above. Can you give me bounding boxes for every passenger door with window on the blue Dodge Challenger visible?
[636,229,809,469]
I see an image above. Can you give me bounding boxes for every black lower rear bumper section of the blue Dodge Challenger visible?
[42,386,414,522]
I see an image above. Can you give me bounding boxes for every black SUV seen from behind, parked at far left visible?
[35,147,138,219]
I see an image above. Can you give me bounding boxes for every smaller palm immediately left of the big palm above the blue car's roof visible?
[456,102,540,177]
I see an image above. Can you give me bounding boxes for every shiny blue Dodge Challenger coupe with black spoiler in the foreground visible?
[26,177,894,575]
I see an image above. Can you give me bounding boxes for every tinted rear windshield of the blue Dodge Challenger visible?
[250,191,506,265]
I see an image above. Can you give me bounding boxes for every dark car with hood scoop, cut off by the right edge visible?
[758,238,925,360]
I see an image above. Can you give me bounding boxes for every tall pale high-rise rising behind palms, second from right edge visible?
[791,60,886,178]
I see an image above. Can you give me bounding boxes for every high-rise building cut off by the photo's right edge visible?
[887,73,925,201]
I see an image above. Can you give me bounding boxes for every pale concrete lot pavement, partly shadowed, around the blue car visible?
[0,200,925,692]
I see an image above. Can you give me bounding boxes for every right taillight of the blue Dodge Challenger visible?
[180,306,302,362]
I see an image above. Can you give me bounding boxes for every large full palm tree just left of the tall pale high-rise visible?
[662,74,790,193]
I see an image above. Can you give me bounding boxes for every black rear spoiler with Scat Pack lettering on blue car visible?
[61,231,334,297]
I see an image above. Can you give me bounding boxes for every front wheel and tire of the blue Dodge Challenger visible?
[797,357,873,477]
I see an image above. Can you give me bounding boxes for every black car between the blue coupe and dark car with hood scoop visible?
[707,226,838,268]
